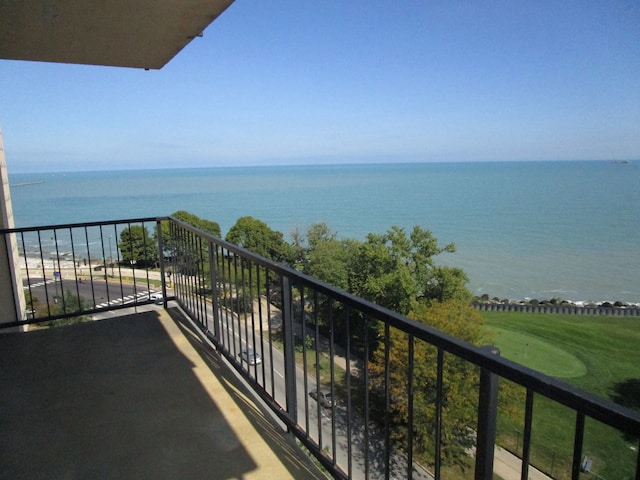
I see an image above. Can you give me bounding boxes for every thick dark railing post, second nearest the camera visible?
[282,276,298,424]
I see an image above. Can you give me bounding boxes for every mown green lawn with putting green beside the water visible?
[481,312,640,480]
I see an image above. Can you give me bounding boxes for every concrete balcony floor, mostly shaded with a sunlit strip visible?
[0,306,326,480]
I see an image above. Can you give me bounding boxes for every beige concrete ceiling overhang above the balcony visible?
[0,0,233,69]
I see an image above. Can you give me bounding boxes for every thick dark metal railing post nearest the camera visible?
[474,346,500,480]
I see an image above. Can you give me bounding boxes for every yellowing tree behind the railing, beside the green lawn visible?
[369,300,482,464]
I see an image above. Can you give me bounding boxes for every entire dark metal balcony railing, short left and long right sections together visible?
[2,217,640,480]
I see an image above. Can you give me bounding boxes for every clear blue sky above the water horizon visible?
[0,0,640,173]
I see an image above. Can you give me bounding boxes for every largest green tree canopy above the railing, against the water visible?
[303,224,471,315]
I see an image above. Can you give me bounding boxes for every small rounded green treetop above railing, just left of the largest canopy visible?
[225,217,293,262]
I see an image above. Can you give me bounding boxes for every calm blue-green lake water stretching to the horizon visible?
[9,162,640,302]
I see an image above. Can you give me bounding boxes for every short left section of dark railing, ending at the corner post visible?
[1,218,166,327]
